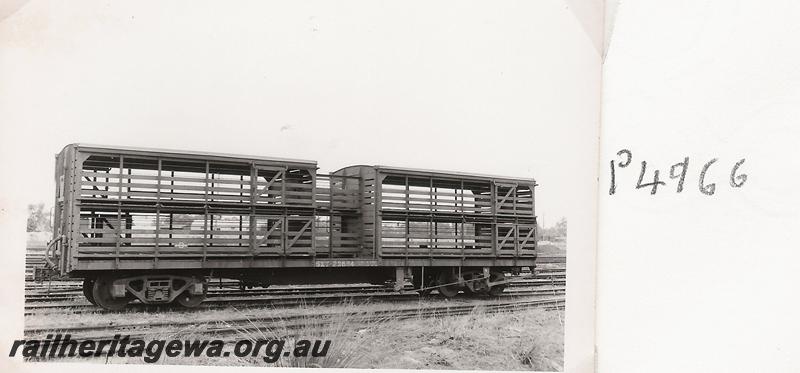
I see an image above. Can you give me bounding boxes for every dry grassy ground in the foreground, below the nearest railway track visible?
[26,301,564,371]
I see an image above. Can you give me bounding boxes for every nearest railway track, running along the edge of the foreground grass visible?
[25,297,564,340]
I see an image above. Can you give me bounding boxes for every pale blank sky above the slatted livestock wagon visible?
[0,0,600,226]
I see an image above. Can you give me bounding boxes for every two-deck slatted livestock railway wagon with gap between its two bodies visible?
[40,144,536,310]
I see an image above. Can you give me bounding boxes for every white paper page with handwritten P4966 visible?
[597,1,800,373]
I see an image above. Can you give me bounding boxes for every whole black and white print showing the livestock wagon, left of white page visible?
[0,0,600,371]
